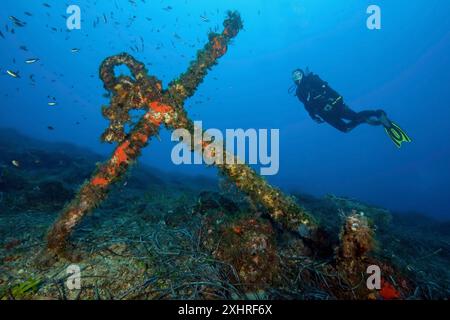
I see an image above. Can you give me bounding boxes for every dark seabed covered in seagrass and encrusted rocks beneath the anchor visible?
[0,129,450,299]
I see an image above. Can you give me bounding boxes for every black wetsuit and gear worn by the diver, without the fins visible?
[296,73,383,132]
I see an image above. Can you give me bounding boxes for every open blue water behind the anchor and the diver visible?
[0,0,450,218]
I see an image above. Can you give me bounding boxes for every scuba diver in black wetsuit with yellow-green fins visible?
[292,69,411,148]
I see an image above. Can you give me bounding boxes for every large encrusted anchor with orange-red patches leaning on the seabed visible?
[47,12,316,255]
